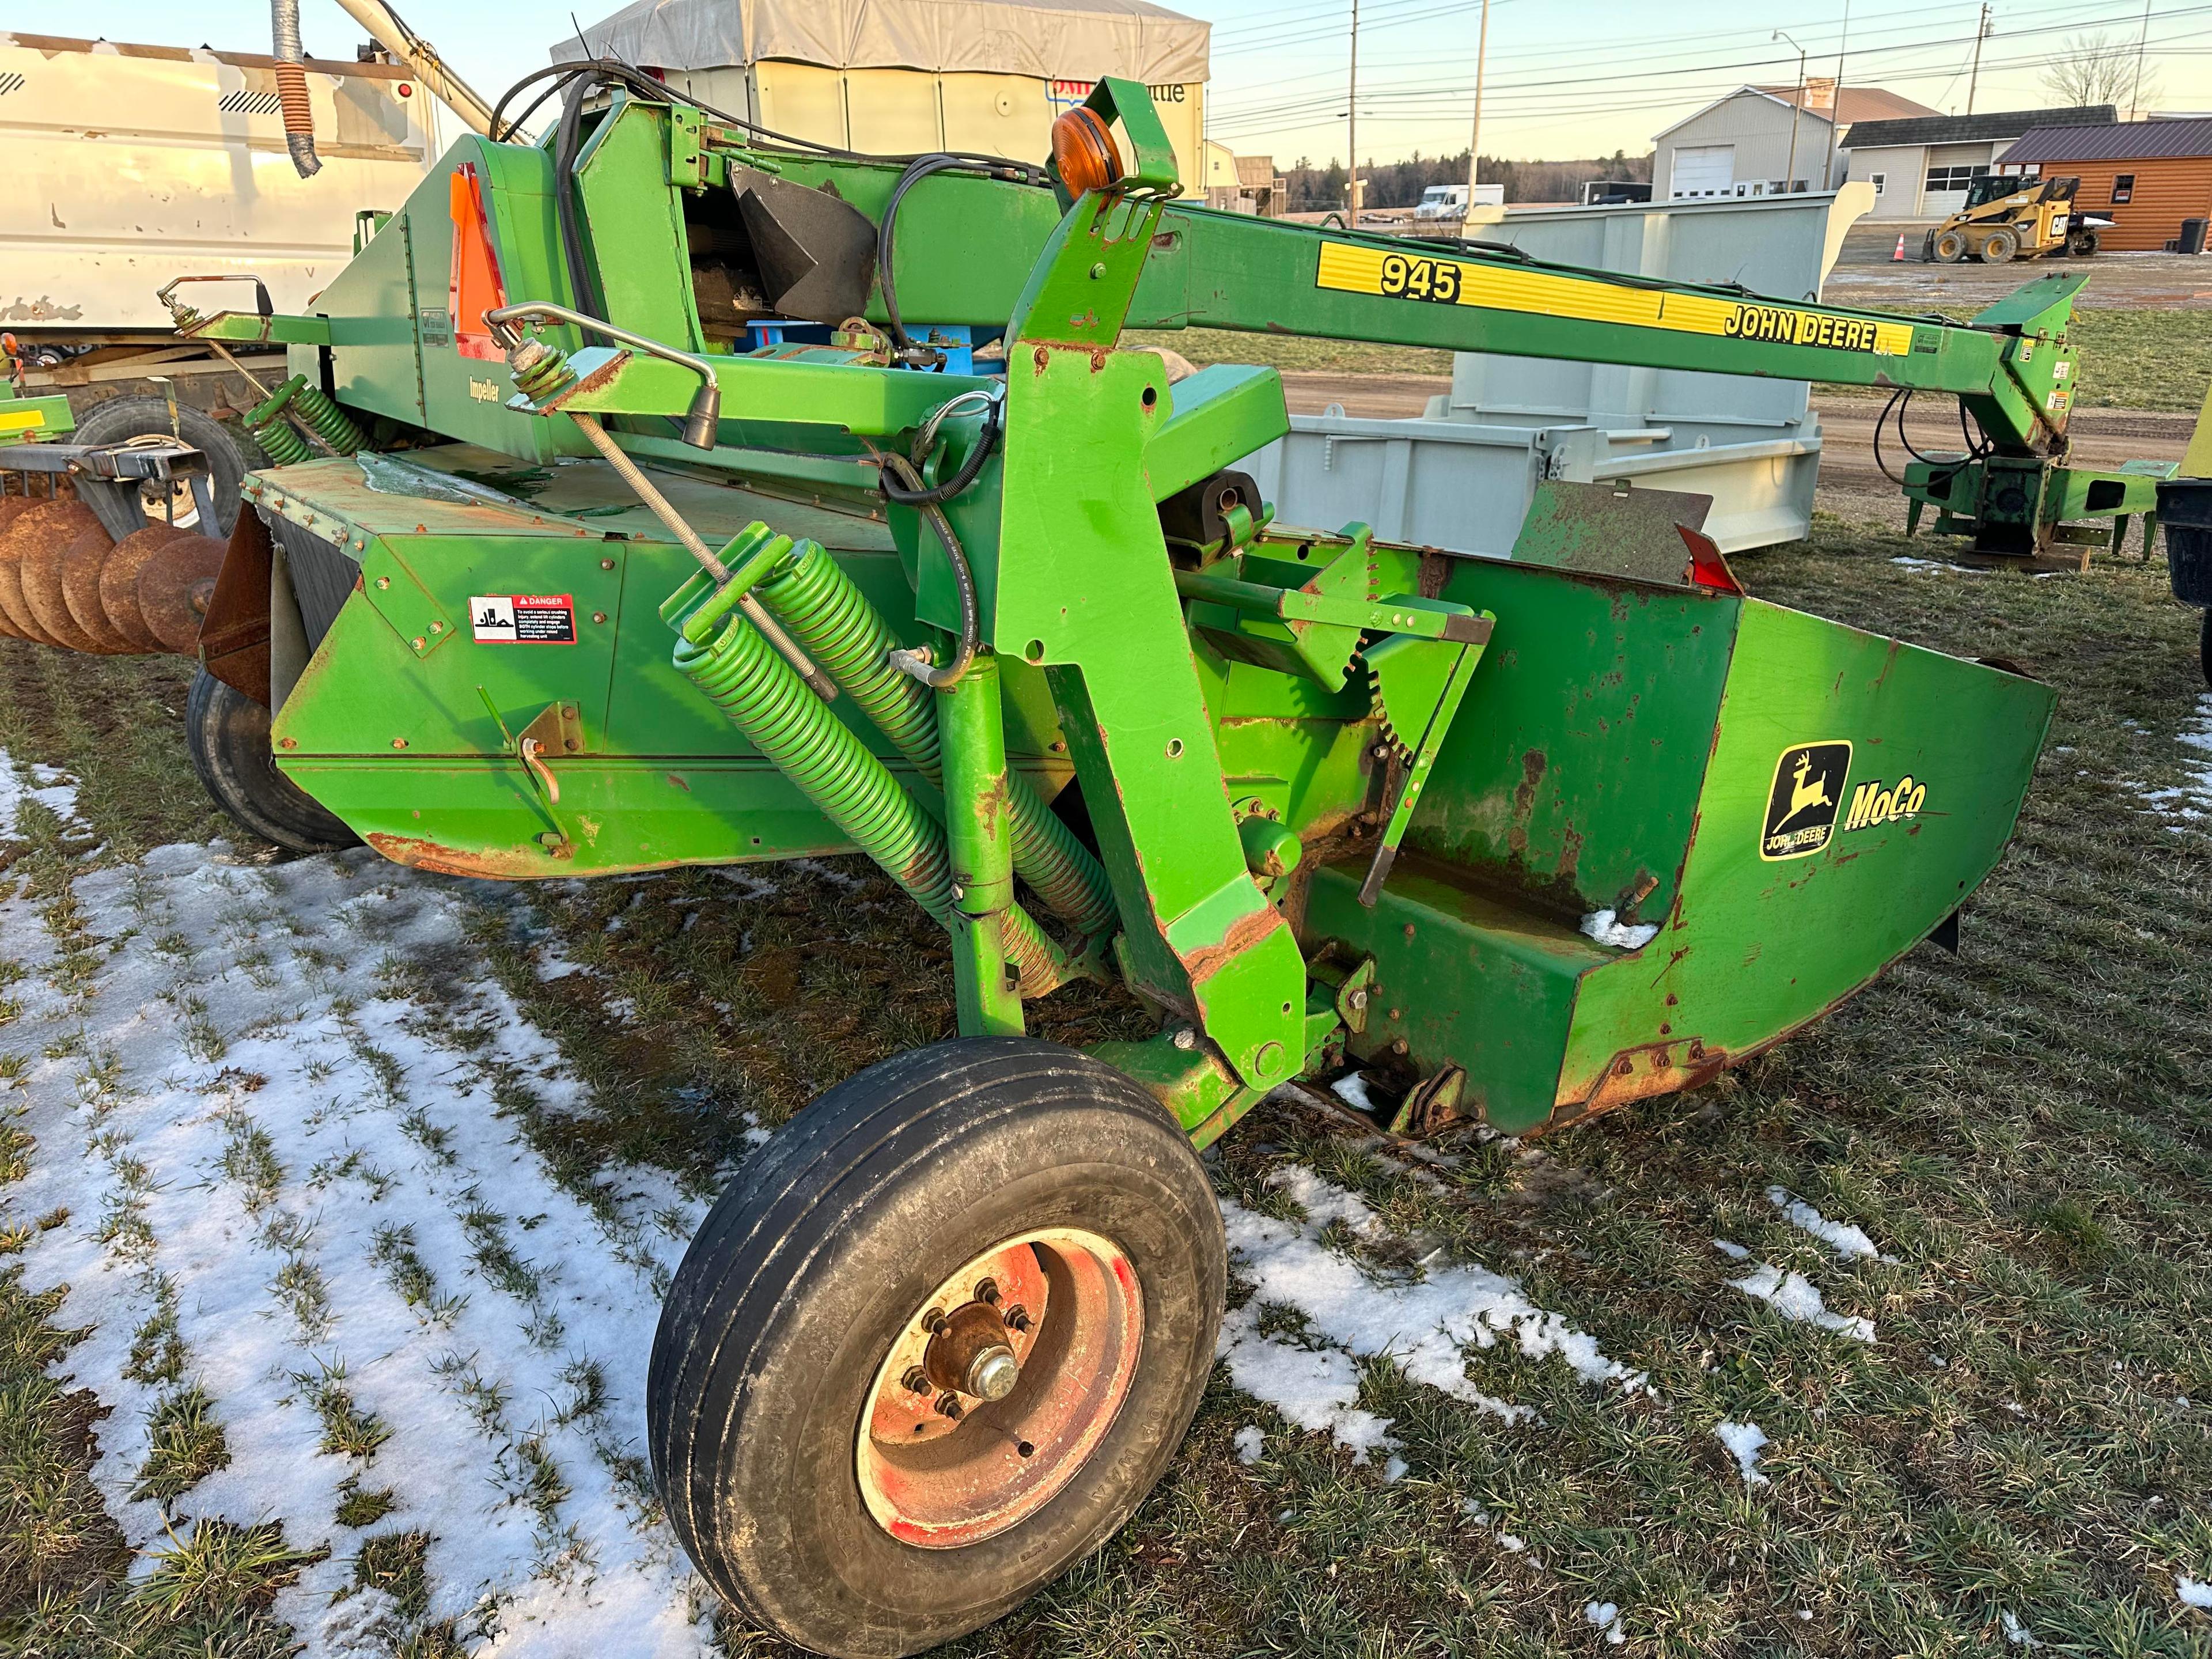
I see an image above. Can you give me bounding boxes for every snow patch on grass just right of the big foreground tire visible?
[1219,1166,1646,1462]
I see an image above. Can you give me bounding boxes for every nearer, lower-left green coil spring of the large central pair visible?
[675,617,1066,995]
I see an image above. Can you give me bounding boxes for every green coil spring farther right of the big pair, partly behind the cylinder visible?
[754,542,1117,933]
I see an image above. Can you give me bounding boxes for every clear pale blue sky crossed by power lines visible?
[17,0,2212,164]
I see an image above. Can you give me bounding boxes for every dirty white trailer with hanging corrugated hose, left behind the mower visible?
[0,31,460,537]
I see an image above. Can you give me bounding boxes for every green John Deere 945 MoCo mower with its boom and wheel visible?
[116,64,2088,1654]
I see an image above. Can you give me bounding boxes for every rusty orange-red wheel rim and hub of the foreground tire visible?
[854,1228,1143,1548]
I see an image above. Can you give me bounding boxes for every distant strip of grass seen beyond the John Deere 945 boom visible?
[1128,310,2212,414]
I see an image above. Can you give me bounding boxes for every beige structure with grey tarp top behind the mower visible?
[553,0,1212,195]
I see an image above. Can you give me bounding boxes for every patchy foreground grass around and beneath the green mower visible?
[0,518,2212,1659]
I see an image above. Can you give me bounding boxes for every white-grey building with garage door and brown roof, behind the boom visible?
[1652,79,1936,201]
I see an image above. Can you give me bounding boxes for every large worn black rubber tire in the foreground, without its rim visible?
[646,1037,1228,1659]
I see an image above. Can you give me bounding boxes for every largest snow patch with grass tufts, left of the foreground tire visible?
[0,849,710,1657]
